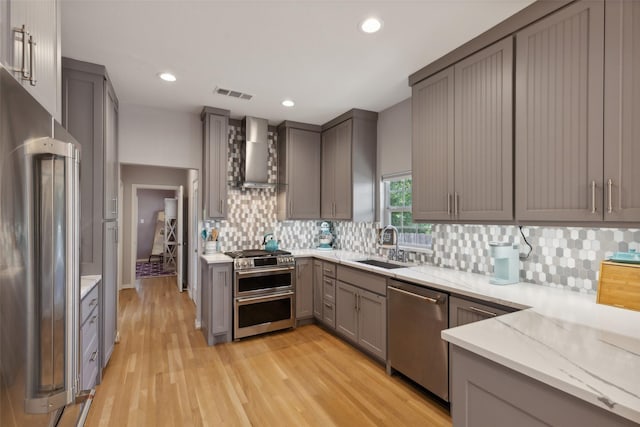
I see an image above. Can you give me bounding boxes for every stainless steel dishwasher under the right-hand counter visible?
[387,280,449,402]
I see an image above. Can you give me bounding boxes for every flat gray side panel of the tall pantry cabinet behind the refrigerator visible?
[62,67,104,274]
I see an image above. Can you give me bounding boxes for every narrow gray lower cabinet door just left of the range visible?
[210,264,232,335]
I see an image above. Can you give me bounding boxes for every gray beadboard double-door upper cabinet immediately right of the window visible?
[412,38,513,221]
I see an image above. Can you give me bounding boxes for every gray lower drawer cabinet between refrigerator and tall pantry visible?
[80,283,101,390]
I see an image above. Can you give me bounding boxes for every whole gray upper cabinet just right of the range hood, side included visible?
[278,122,321,221]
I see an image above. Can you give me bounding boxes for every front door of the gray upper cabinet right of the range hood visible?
[286,128,321,219]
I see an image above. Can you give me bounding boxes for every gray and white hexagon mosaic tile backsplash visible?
[208,121,640,293]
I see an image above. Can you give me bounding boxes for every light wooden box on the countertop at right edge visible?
[597,261,640,311]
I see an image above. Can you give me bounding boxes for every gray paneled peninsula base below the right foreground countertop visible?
[451,345,637,427]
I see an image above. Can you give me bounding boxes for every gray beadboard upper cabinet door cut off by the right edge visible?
[604,0,640,222]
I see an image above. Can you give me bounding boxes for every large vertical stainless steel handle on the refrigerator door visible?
[24,138,80,413]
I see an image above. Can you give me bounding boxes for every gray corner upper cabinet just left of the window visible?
[320,110,378,221]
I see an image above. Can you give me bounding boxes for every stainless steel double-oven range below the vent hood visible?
[226,250,296,340]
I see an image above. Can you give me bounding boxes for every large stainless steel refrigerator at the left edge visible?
[0,66,87,427]
